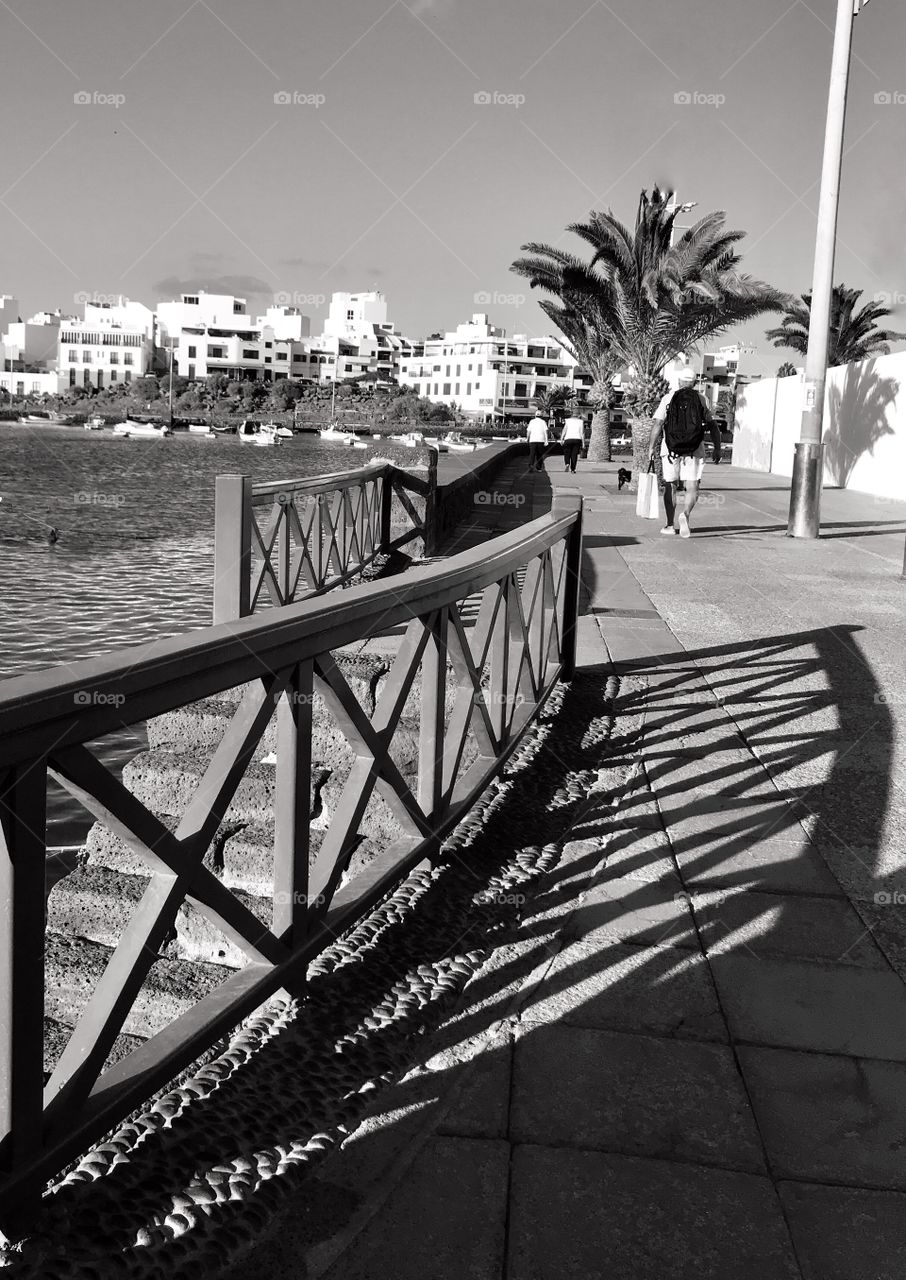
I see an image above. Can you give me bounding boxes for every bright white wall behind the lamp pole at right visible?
[733,351,906,498]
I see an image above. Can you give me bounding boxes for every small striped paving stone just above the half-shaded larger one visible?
[564,877,699,951]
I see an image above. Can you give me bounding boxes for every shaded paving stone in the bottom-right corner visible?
[778,1183,906,1280]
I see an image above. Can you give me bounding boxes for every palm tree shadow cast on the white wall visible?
[824,360,900,489]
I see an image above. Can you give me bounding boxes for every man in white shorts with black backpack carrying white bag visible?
[649,369,720,538]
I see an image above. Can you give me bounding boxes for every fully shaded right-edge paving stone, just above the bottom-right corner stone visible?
[738,1046,906,1190]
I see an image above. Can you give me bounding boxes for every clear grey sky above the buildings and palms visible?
[0,0,906,372]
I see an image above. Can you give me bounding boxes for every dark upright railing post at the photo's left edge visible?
[0,760,47,1234]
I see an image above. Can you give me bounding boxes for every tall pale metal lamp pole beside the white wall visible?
[787,0,868,538]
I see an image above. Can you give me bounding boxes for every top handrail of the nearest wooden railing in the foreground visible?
[0,499,581,765]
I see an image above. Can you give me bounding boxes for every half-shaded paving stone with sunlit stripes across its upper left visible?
[521,940,727,1041]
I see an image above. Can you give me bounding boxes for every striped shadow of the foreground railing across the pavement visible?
[12,614,890,1276]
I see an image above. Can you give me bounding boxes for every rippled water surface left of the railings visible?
[0,422,388,845]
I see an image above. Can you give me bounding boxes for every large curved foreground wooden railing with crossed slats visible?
[0,497,582,1231]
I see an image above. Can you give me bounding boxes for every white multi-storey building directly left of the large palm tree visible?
[398,312,591,419]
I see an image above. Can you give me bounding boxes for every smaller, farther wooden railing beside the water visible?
[214,454,436,623]
